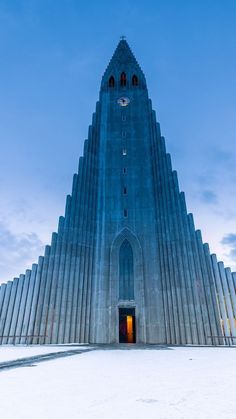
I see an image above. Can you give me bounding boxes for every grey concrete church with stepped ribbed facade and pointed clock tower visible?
[0,40,236,345]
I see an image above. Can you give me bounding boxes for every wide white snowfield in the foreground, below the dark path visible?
[0,348,236,419]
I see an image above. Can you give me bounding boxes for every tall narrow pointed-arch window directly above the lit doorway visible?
[119,239,134,300]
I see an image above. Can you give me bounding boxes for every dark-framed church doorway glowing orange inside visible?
[119,308,136,343]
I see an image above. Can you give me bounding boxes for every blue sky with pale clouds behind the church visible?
[0,0,236,282]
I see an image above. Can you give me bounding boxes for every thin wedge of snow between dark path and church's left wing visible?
[0,345,89,363]
